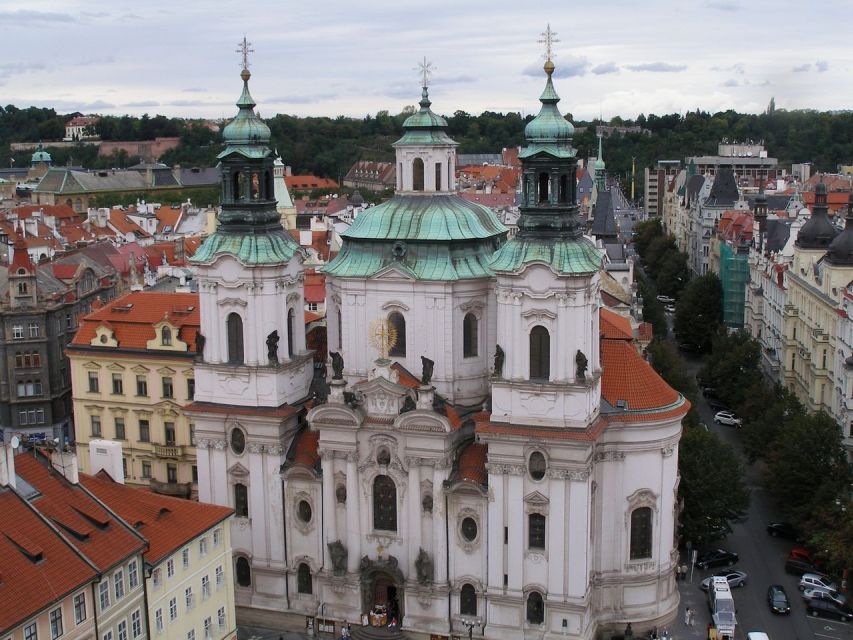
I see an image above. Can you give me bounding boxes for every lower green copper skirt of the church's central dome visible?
[323,240,499,282]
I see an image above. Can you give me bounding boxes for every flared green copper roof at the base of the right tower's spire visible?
[490,237,604,275]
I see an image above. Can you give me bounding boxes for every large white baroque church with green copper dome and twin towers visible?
[188,43,689,640]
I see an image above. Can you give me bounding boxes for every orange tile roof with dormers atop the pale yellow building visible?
[71,291,201,353]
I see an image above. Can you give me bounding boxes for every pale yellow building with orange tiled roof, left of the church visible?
[66,291,203,497]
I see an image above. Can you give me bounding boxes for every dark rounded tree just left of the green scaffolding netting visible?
[674,273,723,353]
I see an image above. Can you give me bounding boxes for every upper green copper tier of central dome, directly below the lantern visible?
[342,194,507,241]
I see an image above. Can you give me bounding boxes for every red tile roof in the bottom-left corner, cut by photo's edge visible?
[0,490,97,633]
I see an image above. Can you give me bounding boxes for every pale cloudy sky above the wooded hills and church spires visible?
[0,0,853,119]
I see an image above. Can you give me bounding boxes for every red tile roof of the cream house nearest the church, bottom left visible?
[80,472,234,564]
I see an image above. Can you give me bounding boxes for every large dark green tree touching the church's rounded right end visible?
[678,427,749,546]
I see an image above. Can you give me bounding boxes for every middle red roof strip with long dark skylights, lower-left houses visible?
[15,454,146,571]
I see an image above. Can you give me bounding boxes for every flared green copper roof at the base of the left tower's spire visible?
[190,227,302,265]
